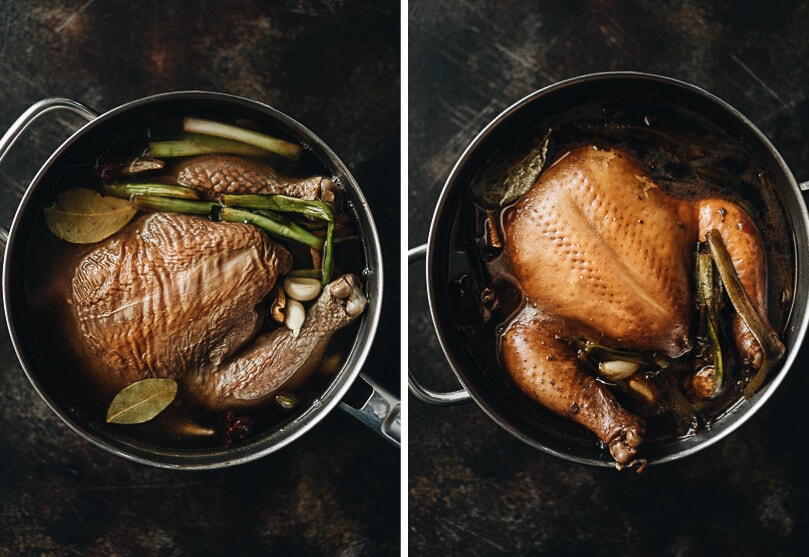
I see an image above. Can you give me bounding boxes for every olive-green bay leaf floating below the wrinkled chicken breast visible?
[107,377,177,424]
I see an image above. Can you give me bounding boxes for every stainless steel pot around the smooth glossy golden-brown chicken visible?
[409,72,809,466]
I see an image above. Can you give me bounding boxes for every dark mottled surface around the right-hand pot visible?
[407,0,809,556]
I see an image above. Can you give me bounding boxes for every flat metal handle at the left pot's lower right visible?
[340,373,402,447]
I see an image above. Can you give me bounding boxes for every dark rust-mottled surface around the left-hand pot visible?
[0,0,401,556]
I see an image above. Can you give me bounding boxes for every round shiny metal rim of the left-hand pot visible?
[2,90,383,469]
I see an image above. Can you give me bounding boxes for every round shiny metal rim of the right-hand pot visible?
[425,71,809,467]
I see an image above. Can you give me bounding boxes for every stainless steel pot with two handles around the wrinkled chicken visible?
[0,91,400,469]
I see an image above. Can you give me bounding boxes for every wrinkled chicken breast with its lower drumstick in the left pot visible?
[70,213,365,408]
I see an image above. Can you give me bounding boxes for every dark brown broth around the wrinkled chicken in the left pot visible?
[25,114,365,451]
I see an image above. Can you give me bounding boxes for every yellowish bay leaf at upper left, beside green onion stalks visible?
[44,188,137,244]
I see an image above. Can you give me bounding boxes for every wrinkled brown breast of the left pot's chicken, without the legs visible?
[71,213,292,384]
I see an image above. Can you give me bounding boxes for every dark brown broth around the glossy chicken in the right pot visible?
[447,97,794,448]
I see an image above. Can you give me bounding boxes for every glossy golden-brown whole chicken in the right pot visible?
[501,147,780,467]
